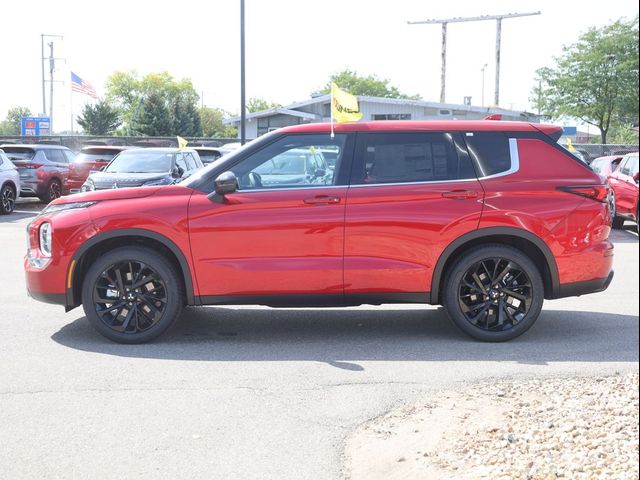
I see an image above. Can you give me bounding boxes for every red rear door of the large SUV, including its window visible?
[344,132,483,299]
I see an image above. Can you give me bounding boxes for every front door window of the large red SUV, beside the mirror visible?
[231,134,346,190]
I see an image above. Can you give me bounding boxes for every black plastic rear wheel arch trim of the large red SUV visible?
[431,227,560,304]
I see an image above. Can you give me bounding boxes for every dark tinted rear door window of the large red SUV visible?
[351,132,475,185]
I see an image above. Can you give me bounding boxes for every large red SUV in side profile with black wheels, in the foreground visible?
[25,121,613,343]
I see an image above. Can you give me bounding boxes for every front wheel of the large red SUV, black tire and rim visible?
[82,247,185,343]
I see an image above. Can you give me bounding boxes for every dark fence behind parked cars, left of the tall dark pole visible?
[0,135,238,152]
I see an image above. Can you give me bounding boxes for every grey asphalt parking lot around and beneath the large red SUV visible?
[0,201,639,479]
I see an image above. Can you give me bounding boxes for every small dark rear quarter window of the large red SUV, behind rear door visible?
[464,132,511,177]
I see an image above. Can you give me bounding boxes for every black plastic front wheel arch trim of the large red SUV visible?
[66,228,197,310]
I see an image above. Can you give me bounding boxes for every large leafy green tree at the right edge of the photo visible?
[532,16,638,143]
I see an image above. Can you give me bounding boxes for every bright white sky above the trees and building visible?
[0,0,638,131]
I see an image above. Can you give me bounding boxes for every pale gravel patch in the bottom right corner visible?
[347,373,638,480]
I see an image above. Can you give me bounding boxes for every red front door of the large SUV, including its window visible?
[189,134,348,303]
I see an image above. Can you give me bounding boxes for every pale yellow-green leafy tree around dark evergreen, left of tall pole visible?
[106,70,200,136]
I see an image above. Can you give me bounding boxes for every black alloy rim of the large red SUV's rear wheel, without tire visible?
[458,258,532,332]
